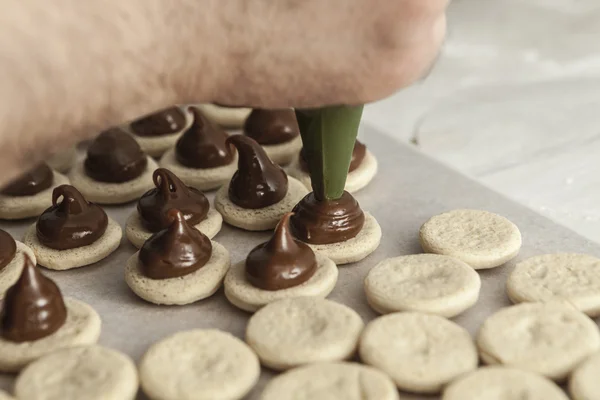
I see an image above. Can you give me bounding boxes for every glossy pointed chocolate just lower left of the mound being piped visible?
[246,213,317,290]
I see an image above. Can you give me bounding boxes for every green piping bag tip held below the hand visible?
[296,105,363,200]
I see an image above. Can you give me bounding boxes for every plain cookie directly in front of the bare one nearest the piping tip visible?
[359,312,478,393]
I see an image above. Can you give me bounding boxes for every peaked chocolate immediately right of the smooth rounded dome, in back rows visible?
[175,107,235,168]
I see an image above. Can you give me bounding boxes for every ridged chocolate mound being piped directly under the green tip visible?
[290,191,365,244]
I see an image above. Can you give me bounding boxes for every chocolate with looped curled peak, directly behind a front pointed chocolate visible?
[137,168,210,232]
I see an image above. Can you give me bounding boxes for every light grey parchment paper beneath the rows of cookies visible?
[0,127,600,400]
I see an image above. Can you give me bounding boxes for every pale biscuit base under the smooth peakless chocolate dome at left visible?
[69,157,158,204]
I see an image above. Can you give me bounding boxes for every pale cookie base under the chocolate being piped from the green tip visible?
[307,212,381,265]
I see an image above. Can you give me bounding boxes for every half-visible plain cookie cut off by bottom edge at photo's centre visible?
[261,362,399,400]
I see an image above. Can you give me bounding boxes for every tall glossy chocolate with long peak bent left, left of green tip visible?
[227,135,288,209]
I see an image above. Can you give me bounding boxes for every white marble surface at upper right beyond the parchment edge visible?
[364,0,600,244]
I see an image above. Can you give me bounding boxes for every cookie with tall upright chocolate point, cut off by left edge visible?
[0,256,101,372]
